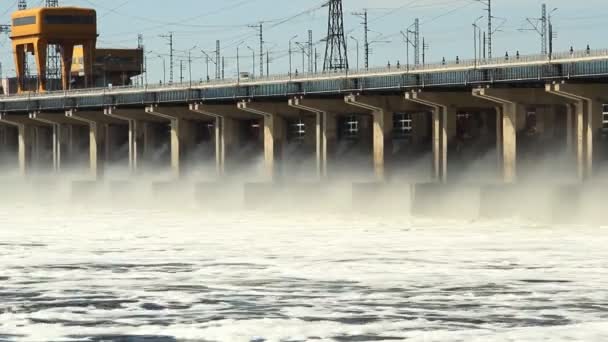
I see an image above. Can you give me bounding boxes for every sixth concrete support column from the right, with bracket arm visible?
[237,101,287,181]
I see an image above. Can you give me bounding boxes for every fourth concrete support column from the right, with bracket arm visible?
[344,95,393,182]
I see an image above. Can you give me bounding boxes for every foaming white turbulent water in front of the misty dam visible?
[0,199,608,342]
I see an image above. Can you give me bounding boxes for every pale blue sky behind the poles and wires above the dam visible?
[0,0,608,83]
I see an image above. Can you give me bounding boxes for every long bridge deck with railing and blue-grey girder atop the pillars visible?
[0,50,608,112]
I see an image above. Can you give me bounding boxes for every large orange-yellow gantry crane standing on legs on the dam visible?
[11,7,97,92]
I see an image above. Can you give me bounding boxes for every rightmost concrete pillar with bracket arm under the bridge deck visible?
[546,83,608,181]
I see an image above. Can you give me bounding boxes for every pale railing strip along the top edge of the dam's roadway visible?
[0,49,608,100]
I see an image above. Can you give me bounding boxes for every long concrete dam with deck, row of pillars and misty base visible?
[0,49,608,215]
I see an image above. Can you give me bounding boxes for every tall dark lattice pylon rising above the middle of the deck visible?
[323,0,348,71]
